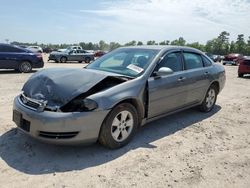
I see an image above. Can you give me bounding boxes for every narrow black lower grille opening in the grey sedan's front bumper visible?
[39,131,79,139]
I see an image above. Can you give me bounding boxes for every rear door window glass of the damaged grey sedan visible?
[183,52,203,70]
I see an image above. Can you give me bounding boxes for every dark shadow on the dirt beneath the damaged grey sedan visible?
[0,105,221,175]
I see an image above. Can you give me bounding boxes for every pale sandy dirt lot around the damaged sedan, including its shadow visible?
[0,54,250,188]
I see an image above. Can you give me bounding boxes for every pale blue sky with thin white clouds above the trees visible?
[0,0,250,43]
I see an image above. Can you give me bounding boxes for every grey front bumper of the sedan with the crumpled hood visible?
[13,96,109,144]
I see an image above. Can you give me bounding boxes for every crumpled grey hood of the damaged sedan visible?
[22,68,109,106]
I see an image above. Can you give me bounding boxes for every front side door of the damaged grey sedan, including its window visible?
[148,51,188,118]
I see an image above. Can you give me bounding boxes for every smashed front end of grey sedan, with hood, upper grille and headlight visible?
[19,69,130,112]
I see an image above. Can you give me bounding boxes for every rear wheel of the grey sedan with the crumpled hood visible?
[199,85,218,112]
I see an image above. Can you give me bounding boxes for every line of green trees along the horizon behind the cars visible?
[12,31,250,55]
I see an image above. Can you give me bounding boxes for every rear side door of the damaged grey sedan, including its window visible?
[183,51,212,105]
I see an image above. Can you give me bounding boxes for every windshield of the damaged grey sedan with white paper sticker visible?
[86,48,159,77]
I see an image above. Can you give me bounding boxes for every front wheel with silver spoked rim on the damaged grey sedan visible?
[98,103,139,149]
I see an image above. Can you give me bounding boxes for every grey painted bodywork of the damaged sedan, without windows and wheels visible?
[13,46,225,144]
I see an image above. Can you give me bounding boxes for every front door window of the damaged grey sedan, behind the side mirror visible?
[157,53,183,72]
